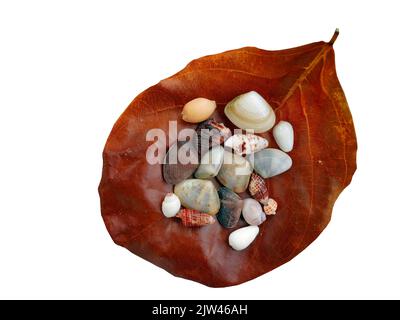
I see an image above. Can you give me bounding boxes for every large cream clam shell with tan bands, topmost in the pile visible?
[224,91,275,133]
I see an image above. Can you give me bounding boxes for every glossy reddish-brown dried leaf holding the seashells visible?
[99,33,357,287]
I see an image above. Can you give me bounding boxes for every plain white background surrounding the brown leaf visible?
[0,0,400,299]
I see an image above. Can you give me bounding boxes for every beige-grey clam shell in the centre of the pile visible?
[217,151,253,193]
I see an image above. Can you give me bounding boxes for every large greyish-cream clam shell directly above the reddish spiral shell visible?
[174,179,220,215]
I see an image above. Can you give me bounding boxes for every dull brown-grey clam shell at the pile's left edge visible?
[163,141,199,184]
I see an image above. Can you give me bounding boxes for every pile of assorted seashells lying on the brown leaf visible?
[162,91,294,250]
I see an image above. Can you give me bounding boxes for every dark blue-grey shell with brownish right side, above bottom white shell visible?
[217,187,243,228]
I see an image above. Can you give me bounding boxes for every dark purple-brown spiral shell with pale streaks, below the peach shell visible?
[196,119,232,155]
